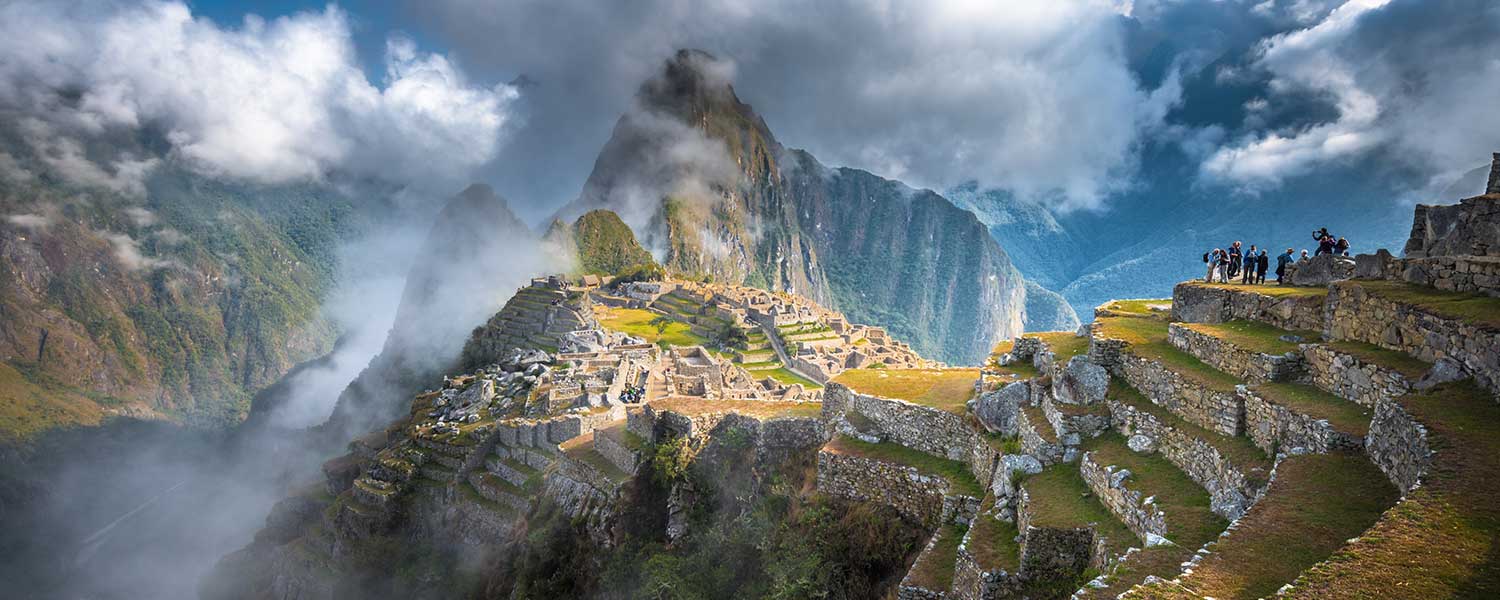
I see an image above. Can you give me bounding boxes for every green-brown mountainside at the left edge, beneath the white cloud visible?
[0,165,348,441]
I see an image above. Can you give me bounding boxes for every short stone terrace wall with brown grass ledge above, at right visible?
[1242,383,1373,455]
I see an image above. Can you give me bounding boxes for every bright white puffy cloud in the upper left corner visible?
[0,2,516,192]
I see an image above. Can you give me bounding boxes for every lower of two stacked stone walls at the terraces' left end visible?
[818,452,950,528]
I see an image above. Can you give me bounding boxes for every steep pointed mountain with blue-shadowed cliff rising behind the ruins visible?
[560,51,1077,363]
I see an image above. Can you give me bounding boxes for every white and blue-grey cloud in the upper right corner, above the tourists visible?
[1203,0,1500,188]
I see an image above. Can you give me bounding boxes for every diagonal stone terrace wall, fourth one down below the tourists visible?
[1106,378,1272,519]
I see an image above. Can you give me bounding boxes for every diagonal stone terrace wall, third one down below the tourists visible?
[1116,354,1245,435]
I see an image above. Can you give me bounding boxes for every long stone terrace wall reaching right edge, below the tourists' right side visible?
[1328,281,1500,392]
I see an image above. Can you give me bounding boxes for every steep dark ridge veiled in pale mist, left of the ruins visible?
[324,185,542,440]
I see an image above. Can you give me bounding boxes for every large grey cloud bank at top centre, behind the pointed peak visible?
[410,0,1163,218]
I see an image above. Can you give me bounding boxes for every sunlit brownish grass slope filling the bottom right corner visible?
[1278,381,1500,599]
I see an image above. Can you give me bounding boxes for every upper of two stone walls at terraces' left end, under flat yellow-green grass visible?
[824,383,984,462]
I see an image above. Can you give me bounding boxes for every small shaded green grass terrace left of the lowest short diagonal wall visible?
[1022,464,1140,551]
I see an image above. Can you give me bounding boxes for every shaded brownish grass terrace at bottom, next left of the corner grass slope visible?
[1127,453,1398,600]
